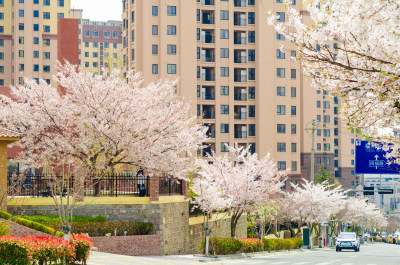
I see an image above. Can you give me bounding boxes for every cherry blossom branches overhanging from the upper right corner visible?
[268,0,400,157]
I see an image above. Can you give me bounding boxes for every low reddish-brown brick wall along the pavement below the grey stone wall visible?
[92,235,161,256]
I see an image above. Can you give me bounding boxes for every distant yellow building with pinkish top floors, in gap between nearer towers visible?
[71,9,123,74]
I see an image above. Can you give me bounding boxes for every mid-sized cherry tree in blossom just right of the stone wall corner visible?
[194,144,285,237]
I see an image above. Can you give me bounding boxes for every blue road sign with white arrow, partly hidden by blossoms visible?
[356,140,400,174]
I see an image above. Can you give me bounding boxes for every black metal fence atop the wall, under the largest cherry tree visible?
[8,174,183,197]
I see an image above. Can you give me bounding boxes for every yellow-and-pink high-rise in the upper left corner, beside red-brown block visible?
[0,0,71,86]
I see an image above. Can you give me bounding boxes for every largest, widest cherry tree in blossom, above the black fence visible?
[0,60,205,179]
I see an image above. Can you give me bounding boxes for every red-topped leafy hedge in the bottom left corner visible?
[0,235,93,265]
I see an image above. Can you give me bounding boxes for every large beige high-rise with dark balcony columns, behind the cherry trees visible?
[122,0,358,187]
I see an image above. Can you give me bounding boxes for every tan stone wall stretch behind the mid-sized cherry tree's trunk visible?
[188,214,247,253]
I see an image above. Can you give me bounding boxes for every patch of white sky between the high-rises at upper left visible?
[71,0,122,21]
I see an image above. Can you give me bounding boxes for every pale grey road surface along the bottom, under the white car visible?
[88,243,400,265]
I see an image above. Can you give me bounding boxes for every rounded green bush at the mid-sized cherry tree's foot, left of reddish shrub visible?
[200,237,243,255]
